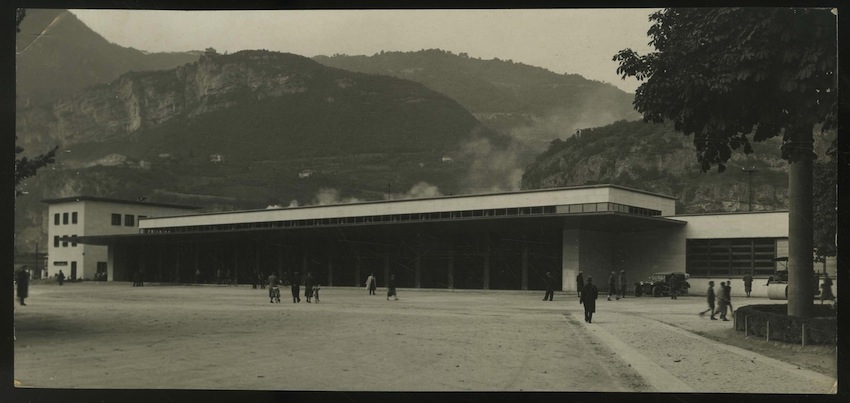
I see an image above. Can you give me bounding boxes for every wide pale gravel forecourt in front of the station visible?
[14,282,837,394]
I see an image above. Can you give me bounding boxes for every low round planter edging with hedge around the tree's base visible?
[734,304,838,346]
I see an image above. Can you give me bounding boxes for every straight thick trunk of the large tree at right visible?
[788,130,815,318]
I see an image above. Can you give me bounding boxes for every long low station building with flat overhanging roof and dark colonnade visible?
[53,185,820,296]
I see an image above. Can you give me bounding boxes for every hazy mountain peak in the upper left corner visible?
[15,9,201,106]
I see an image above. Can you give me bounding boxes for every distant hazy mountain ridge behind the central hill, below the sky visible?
[314,49,640,153]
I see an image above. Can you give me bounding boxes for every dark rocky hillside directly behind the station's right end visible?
[521,121,835,213]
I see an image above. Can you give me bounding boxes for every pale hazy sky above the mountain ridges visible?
[72,8,655,92]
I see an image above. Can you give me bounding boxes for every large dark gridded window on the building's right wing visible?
[686,238,776,277]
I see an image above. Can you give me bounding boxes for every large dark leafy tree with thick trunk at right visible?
[614,8,837,317]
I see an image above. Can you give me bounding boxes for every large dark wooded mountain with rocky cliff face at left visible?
[15,50,519,254]
